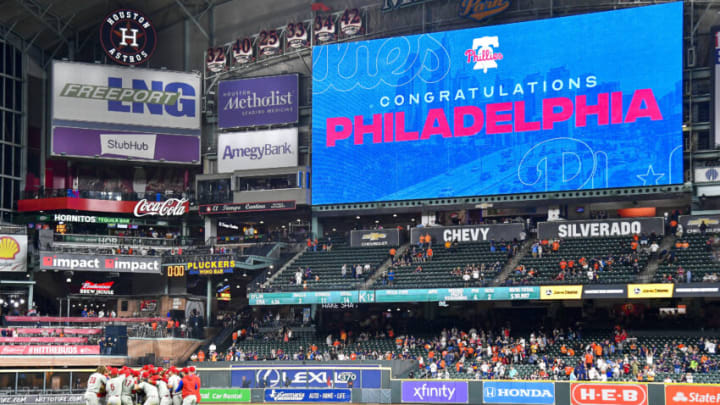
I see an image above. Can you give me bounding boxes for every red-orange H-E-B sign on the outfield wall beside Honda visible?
[570,384,648,405]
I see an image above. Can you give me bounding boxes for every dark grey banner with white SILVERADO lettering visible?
[538,217,665,239]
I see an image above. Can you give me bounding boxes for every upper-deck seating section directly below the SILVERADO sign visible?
[507,237,648,285]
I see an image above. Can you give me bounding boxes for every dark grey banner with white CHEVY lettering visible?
[410,224,525,244]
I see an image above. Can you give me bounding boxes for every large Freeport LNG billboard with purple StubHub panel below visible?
[51,61,201,164]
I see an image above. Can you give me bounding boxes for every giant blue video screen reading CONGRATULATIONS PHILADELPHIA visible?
[312,2,683,204]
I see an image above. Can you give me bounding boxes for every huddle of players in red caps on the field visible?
[84,365,200,405]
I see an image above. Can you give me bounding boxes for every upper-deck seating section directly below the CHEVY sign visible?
[375,242,508,289]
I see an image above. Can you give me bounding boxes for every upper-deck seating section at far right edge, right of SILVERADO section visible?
[655,234,720,283]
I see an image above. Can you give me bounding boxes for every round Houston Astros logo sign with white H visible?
[100,10,157,65]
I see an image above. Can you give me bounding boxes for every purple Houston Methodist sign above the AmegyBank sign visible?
[218,74,298,129]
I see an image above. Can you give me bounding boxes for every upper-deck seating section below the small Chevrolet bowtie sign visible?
[269,240,389,291]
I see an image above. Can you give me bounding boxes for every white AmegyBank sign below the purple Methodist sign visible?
[218,128,298,173]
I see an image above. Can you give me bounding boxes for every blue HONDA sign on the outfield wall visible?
[483,381,555,405]
